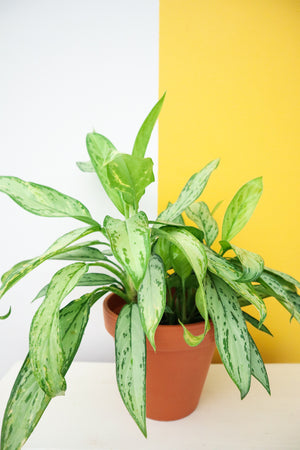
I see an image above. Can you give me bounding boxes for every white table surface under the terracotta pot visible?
[0,362,300,450]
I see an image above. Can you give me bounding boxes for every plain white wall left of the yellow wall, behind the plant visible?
[0,0,158,377]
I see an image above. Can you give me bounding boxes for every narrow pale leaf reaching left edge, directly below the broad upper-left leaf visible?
[0,227,99,298]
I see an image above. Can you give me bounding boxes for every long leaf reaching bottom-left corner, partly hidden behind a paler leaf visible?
[1,294,92,450]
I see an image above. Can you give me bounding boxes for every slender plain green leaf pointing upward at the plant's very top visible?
[132,93,166,158]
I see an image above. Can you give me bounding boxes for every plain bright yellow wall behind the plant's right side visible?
[158,0,300,362]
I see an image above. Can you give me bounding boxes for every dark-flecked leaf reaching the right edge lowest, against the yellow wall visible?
[259,272,300,322]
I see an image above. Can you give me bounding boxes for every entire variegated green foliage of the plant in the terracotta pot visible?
[0,96,300,450]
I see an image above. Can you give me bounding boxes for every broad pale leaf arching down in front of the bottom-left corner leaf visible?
[29,263,87,397]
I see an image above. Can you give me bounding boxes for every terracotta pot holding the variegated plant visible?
[103,294,215,420]
